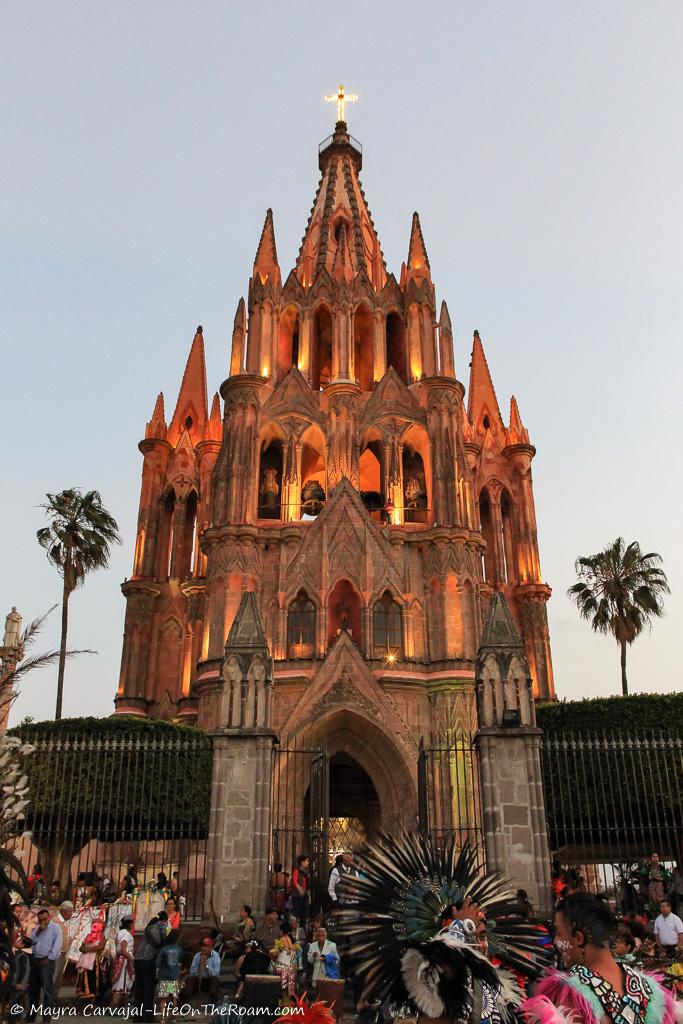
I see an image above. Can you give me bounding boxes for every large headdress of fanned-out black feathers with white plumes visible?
[335,831,551,1018]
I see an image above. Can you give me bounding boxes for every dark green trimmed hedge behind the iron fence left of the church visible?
[7,717,212,855]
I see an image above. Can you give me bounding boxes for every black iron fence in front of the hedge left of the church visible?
[8,732,212,919]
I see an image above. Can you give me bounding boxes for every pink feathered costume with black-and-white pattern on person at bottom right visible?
[524,964,676,1024]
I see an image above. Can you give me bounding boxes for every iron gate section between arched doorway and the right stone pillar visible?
[418,730,484,858]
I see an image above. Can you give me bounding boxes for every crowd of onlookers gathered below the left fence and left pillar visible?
[0,854,355,1021]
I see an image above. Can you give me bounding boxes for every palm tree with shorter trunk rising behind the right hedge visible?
[567,537,671,696]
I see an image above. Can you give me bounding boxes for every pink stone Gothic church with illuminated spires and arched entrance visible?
[115,121,554,828]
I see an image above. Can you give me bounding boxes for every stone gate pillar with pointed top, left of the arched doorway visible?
[200,591,278,922]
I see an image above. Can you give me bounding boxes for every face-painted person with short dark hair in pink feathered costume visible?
[524,893,678,1024]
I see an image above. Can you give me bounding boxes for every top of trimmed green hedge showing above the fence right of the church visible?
[536,693,683,735]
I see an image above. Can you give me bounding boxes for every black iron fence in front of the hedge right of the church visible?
[541,730,683,909]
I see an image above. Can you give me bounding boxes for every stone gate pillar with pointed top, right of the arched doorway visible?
[476,593,552,912]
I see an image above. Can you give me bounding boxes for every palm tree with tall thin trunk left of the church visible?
[36,487,121,719]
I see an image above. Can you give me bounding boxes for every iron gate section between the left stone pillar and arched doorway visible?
[270,742,330,909]
